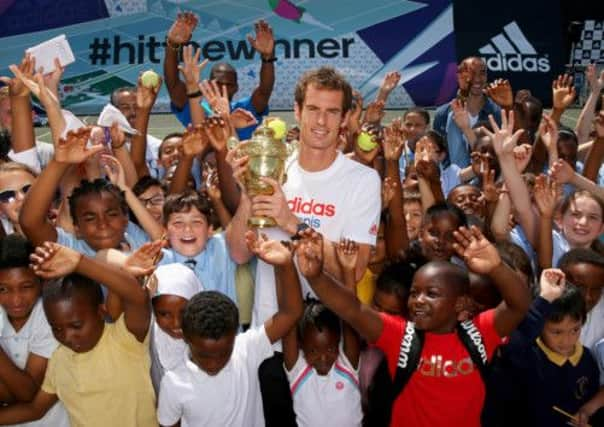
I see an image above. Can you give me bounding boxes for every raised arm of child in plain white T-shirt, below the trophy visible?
[245,231,303,346]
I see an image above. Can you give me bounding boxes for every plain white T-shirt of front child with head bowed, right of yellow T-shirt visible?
[157,326,273,427]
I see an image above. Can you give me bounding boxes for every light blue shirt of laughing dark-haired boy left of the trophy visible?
[159,233,237,304]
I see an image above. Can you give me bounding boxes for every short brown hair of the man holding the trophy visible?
[294,67,352,114]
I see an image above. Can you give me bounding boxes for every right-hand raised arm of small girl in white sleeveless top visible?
[336,239,361,369]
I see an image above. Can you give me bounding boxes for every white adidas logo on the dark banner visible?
[478,21,551,73]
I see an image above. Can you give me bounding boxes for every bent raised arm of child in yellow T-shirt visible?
[31,242,151,342]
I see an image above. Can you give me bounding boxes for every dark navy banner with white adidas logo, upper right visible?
[454,0,566,105]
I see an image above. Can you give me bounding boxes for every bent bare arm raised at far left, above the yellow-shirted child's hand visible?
[19,127,104,245]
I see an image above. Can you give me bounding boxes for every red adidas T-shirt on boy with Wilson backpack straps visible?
[374,310,501,427]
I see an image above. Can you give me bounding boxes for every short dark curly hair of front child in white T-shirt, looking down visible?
[182,291,239,340]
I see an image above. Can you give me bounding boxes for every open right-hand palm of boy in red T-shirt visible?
[453,225,501,274]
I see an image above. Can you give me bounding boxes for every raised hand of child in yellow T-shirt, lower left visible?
[29,242,82,279]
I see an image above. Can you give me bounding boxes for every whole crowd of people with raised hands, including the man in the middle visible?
[0,12,604,427]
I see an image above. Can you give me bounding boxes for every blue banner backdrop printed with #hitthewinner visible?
[0,0,456,114]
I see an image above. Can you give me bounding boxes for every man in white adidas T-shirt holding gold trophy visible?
[230,67,381,426]
